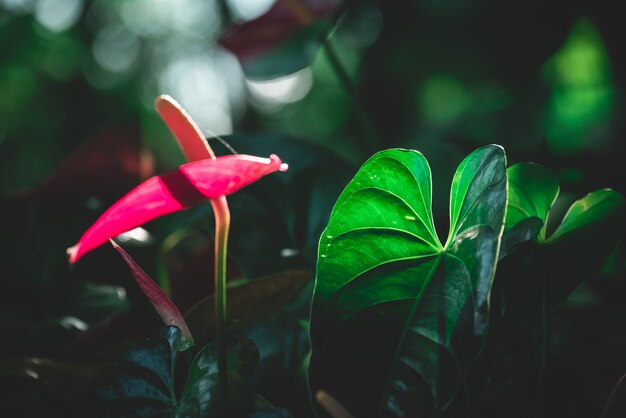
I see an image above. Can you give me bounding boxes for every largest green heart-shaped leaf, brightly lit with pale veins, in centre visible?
[310,145,507,416]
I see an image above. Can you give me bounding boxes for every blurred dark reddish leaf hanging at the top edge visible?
[219,0,338,61]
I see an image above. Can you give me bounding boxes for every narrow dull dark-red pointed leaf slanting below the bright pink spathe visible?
[111,240,194,351]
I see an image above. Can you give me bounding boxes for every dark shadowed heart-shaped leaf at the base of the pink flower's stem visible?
[84,326,259,417]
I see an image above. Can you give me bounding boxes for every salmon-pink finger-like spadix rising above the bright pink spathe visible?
[154,95,215,162]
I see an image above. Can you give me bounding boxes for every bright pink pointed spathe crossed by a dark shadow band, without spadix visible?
[67,154,287,263]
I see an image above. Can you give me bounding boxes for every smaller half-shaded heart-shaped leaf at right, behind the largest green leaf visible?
[501,163,625,310]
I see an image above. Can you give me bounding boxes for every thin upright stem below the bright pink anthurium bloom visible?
[211,196,230,417]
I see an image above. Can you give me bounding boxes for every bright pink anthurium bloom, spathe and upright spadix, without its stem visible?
[67,96,287,263]
